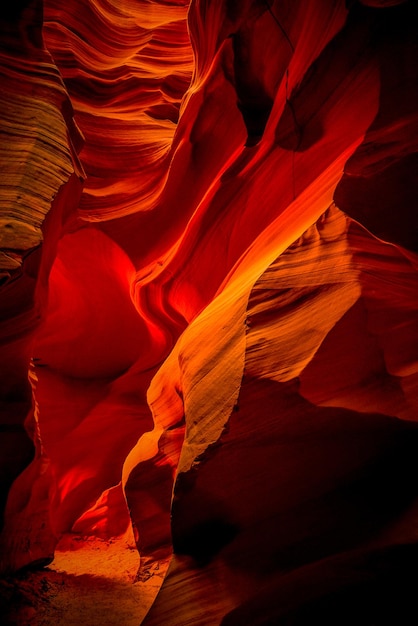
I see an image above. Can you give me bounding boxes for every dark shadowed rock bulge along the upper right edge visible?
[334,1,418,251]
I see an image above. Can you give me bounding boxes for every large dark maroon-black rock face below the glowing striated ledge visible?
[172,379,418,577]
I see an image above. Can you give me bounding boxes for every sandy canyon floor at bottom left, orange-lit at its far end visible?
[0,537,165,626]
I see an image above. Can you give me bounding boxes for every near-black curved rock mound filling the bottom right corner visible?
[221,545,418,626]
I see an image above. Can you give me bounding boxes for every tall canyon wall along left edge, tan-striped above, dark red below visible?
[0,2,84,568]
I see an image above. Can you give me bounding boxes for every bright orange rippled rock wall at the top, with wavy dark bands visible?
[44,0,193,221]
